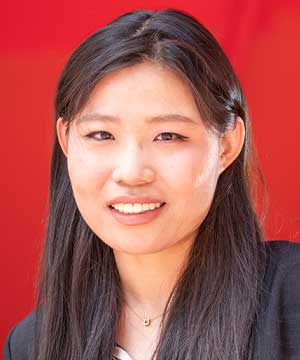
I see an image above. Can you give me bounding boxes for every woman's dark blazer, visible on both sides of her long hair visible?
[4,240,300,360]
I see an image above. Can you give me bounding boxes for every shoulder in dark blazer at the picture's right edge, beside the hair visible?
[255,240,300,360]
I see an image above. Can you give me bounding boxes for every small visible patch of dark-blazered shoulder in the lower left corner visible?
[4,310,36,360]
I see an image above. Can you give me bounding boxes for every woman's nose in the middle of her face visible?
[112,144,155,185]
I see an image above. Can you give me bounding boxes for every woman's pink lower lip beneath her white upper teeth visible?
[108,204,166,225]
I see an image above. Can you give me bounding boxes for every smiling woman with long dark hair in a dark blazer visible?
[5,9,300,360]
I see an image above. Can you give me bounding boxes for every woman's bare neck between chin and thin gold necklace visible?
[114,238,193,318]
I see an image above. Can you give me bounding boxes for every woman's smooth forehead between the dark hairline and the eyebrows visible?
[79,62,199,117]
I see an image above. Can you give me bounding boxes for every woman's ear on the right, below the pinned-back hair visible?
[219,116,245,174]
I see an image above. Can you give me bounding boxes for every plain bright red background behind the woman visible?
[0,0,300,348]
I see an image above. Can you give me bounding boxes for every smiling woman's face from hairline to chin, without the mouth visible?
[57,63,223,254]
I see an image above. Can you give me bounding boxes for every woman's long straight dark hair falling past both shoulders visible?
[32,9,267,360]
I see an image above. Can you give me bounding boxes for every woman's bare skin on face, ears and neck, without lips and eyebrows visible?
[56,62,245,359]
